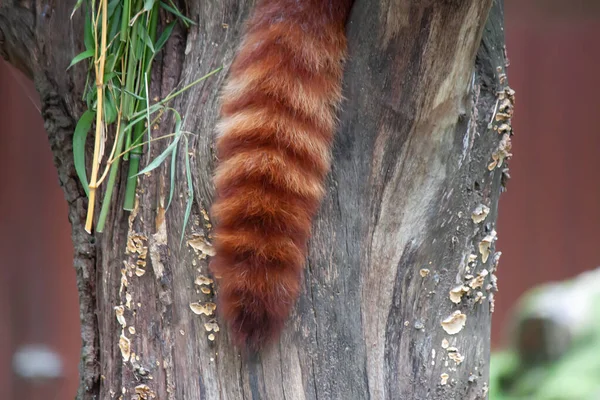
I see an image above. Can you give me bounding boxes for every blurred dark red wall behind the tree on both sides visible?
[0,0,600,400]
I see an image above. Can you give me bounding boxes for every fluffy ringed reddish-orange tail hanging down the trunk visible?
[211,0,352,350]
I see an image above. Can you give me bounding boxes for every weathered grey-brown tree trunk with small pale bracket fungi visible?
[0,0,513,400]
